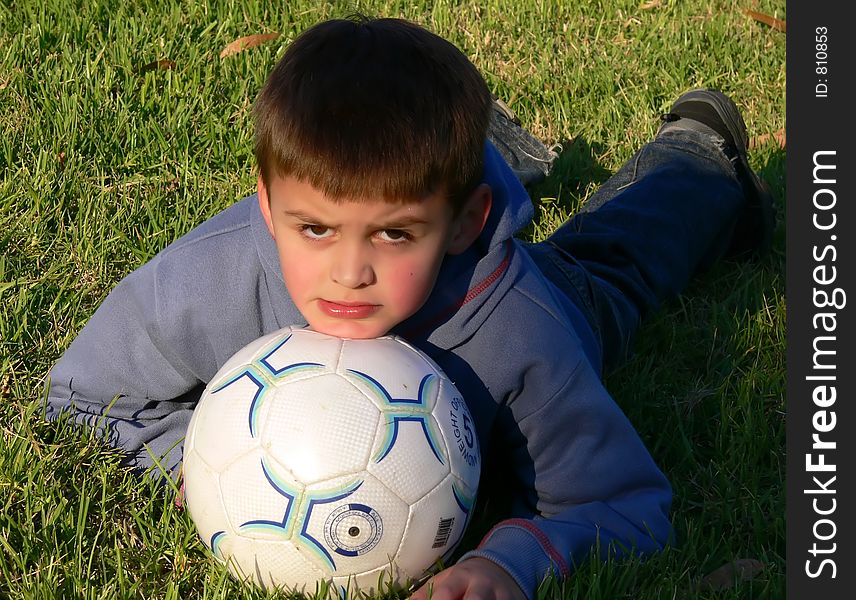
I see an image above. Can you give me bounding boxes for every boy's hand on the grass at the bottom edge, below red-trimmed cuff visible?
[411,557,526,600]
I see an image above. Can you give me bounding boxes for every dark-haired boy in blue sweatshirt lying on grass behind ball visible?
[41,17,772,598]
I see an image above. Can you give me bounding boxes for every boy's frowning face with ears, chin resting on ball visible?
[259,176,490,338]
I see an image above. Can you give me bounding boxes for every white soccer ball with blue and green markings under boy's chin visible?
[183,327,481,595]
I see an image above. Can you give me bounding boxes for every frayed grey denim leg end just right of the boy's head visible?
[487,99,558,186]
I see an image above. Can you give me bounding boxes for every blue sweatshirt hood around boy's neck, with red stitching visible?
[248,142,534,348]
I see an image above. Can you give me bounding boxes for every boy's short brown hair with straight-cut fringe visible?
[254,15,491,209]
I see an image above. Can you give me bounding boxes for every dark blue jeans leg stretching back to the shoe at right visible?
[528,130,746,368]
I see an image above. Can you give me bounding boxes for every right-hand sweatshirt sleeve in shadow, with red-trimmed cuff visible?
[461,352,671,598]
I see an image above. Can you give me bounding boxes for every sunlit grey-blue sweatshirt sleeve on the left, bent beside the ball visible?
[46,259,201,480]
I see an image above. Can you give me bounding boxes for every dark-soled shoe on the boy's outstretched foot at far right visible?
[657,89,775,257]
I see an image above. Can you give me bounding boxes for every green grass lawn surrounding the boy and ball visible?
[0,0,786,599]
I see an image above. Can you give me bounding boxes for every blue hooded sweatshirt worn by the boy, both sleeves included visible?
[47,144,671,598]
